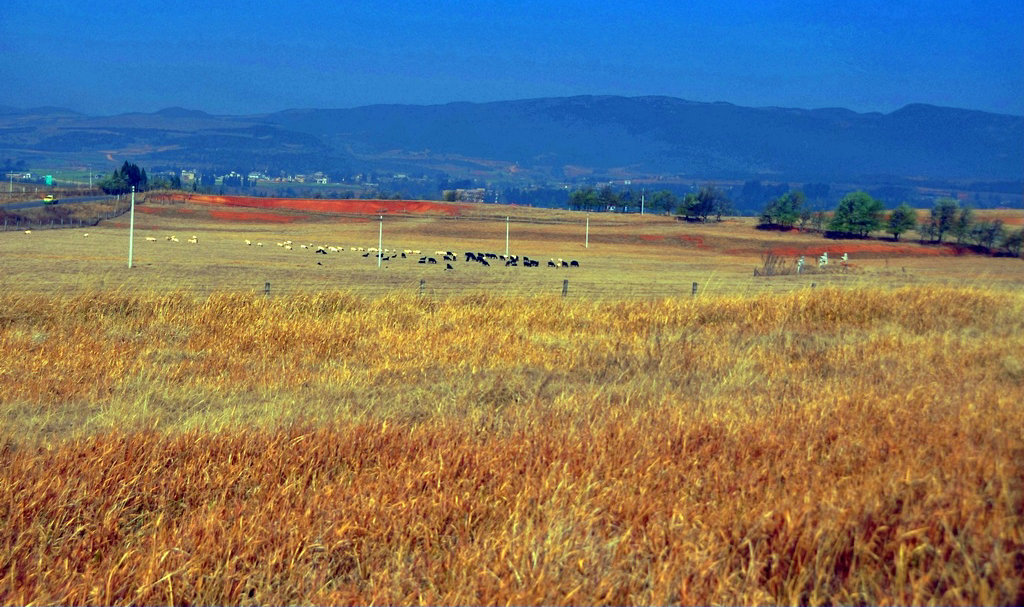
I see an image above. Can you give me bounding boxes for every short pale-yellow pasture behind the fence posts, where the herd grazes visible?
[0,196,1024,299]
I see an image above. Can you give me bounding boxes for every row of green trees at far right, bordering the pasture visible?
[758,190,1024,256]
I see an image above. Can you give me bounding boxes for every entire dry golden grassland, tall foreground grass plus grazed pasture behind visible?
[0,196,1024,605]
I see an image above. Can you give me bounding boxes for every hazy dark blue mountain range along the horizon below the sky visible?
[0,96,1024,182]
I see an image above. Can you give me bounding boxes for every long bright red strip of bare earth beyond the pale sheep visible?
[158,194,464,215]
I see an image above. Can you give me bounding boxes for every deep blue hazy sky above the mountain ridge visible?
[0,0,1024,115]
